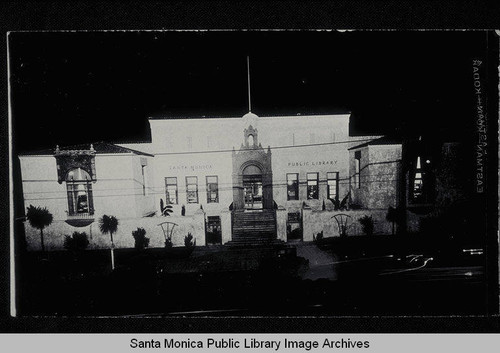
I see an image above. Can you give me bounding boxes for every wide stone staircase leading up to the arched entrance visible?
[227,209,281,246]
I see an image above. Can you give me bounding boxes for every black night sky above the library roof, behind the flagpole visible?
[9,32,486,151]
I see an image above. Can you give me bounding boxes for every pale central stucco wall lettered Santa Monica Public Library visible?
[150,115,350,215]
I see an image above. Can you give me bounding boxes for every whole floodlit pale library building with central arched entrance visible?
[19,113,401,249]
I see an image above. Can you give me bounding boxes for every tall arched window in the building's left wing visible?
[66,168,94,216]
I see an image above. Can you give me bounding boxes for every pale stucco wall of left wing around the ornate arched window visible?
[19,154,158,249]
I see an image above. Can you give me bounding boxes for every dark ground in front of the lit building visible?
[18,236,490,316]
